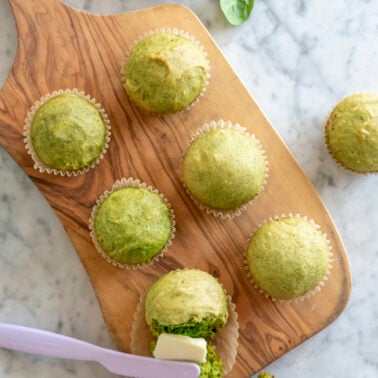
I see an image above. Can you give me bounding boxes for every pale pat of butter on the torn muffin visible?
[153,333,207,363]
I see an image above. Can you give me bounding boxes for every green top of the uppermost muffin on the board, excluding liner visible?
[123,32,209,113]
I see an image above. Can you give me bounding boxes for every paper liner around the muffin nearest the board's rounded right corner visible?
[244,213,333,303]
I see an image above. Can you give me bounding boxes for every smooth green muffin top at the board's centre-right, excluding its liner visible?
[183,128,265,209]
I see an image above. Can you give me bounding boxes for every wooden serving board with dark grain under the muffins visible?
[0,0,351,378]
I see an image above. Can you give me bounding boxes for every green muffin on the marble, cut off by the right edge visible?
[326,93,378,173]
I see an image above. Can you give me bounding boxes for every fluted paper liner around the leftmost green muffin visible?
[23,88,111,177]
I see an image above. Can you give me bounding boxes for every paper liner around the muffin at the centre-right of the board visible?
[181,120,269,219]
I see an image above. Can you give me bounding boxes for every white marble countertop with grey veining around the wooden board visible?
[0,0,378,378]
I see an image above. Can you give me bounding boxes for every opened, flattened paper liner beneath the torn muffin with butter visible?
[130,268,239,376]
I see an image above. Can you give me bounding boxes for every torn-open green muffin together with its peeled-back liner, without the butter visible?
[131,269,238,378]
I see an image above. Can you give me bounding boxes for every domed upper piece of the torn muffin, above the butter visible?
[145,269,228,339]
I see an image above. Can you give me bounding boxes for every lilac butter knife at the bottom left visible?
[0,323,200,378]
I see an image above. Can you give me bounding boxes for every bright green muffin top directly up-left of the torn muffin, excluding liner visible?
[94,187,172,265]
